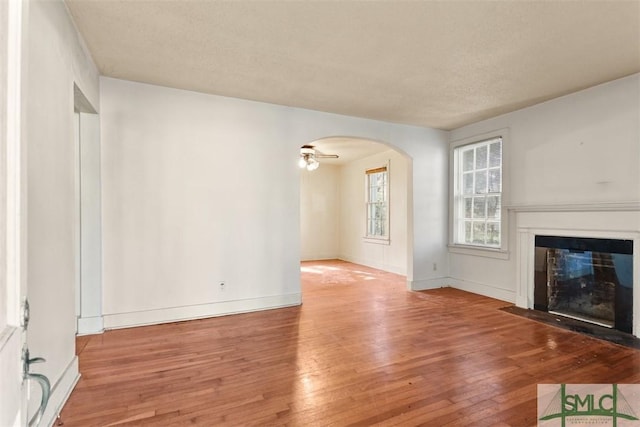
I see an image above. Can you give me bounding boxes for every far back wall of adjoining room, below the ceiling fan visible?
[300,163,340,261]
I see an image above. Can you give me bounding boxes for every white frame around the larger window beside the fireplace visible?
[449,129,509,259]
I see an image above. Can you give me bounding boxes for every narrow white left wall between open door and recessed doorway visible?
[25,1,98,424]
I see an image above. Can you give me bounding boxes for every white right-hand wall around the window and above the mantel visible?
[450,74,640,301]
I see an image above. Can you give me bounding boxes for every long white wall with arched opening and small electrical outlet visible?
[100,78,447,327]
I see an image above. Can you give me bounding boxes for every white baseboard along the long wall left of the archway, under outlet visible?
[103,294,302,329]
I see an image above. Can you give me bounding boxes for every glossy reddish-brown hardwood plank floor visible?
[61,261,640,427]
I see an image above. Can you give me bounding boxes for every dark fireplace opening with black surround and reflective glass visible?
[534,236,633,333]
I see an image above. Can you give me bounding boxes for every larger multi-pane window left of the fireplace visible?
[454,137,502,248]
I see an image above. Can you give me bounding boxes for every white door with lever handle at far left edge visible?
[0,0,49,427]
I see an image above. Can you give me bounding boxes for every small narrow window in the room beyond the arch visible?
[365,166,389,239]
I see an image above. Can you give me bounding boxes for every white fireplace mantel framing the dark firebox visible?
[516,210,640,337]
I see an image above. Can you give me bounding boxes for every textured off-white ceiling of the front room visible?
[67,0,640,129]
